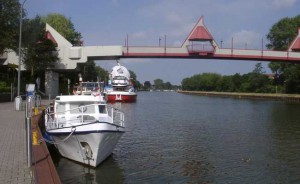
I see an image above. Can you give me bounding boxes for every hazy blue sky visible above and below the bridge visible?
[25,0,300,85]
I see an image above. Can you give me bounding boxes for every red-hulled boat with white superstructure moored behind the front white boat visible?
[104,62,137,103]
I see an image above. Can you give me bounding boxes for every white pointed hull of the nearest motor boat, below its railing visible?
[48,124,124,167]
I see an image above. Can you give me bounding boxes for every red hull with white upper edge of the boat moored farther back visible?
[106,91,137,103]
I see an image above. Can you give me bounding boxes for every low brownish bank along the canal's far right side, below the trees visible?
[177,90,300,103]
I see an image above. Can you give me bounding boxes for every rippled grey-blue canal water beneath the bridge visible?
[51,92,300,183]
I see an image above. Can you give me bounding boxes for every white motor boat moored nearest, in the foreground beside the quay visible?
[45,95,125,167]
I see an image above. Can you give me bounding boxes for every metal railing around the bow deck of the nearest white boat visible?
[45,104,124,129]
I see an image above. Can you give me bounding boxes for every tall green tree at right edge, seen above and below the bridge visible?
[267,15,300,93]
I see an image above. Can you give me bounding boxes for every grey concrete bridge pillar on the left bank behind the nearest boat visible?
[45,70,59,98]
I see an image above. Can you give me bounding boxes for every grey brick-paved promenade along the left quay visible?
[0,102,34,184]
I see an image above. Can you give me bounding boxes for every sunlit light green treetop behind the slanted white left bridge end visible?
[42,13,82,45]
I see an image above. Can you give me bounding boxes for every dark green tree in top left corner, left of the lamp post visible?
[0,0,24,55]
